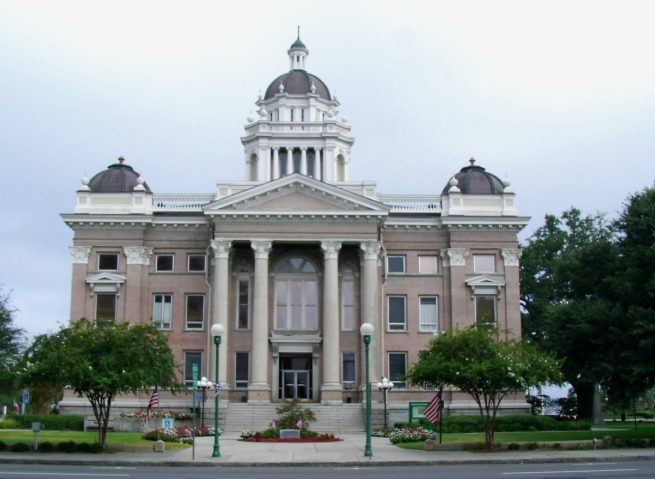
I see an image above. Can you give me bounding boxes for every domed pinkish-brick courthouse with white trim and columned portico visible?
[62,33,528,418]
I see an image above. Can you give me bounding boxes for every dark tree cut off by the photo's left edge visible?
[0,291,25,408]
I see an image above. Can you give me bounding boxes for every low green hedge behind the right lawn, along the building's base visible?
[394,415,591,433]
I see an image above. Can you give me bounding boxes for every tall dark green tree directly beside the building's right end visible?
[520,208,621,419]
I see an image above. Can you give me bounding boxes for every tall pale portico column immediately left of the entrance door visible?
[248,240,272,402]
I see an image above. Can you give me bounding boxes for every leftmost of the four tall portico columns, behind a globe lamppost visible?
[207,239,232,387]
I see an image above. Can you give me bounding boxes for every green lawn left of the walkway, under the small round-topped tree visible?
[0,430,188,449]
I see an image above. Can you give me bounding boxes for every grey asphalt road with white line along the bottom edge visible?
[0,461,655,479]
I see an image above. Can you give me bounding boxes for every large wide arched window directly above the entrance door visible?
[275,256,318,331]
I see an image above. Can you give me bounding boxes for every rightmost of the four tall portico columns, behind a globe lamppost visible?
[360,241,385,384]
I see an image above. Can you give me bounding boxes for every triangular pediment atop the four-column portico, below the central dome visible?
[204,174,388,216]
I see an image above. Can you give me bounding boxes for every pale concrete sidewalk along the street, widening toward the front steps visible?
[0,434,655,467]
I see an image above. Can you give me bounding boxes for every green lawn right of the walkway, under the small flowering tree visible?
[397,423,655,450]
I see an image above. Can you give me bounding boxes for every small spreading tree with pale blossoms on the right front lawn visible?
[408,327,560,450]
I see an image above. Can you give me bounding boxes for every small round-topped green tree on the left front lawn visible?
[21,319,181,446]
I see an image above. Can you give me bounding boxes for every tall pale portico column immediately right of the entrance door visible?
[321,241,342,403]
